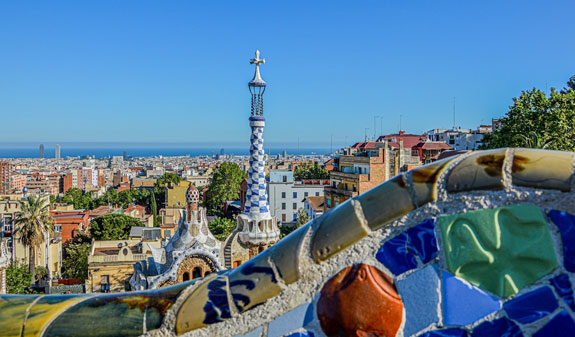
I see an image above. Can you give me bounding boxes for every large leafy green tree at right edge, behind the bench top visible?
[482,88,575,151]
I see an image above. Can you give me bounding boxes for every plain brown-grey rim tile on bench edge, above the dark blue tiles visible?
[357,175,415,230]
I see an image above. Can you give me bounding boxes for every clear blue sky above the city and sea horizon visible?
[0,0,575,146]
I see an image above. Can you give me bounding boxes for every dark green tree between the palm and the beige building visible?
[62,234,91,280]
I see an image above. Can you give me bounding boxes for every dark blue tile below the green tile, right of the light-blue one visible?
[503,287,558,324]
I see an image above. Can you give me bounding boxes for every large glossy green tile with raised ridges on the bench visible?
[438,205,558,297]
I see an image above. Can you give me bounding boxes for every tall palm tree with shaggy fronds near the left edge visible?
[14,196,53,275]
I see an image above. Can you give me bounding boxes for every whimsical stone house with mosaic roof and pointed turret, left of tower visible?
[130,185,223,290]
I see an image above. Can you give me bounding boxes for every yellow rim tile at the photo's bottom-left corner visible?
[0,295,38,336]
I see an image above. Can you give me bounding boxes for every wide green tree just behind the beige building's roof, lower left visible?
[90,214,142,240]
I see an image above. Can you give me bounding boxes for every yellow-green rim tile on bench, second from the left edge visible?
[24,295,88,336]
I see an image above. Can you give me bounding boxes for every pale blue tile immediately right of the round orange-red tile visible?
[396,265,439,336]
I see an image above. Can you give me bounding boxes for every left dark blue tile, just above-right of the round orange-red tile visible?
[375,233,417,275]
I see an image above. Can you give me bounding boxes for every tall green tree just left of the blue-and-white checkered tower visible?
[206,163,247,212]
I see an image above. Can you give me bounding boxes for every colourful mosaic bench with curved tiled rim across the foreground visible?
[0,149,575,337]
